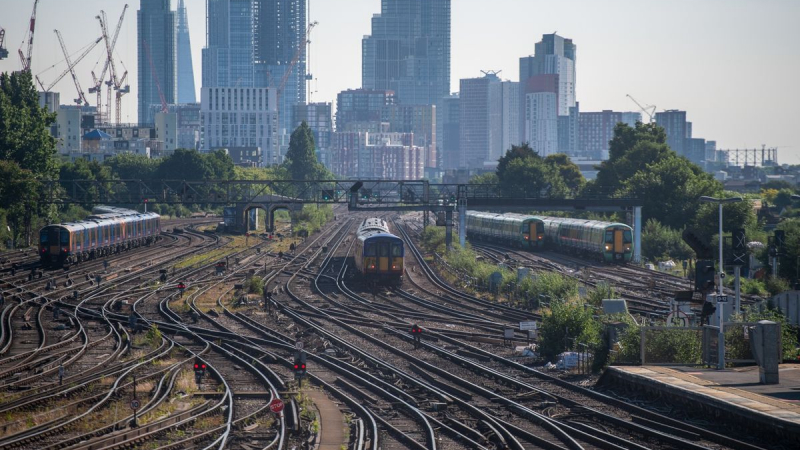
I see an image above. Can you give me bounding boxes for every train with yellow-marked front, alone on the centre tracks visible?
[354,218,405,285]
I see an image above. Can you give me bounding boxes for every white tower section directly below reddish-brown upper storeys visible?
[524,92,558,156]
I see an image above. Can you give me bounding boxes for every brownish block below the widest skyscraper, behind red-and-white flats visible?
[381,105,438,167]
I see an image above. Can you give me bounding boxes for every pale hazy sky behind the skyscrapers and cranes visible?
[0,0,800,164]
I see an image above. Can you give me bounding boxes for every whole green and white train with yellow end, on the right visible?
[466,211,633,264]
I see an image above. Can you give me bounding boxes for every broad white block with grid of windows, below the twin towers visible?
[200,87,281,166]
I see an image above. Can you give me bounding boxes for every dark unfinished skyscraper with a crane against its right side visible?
[254,0,307,140]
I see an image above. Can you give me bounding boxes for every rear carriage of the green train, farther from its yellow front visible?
[466,211,545,249]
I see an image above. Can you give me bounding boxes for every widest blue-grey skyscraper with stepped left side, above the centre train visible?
[361,0,450,105]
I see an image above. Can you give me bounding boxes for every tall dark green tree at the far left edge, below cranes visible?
[0,72,57,179]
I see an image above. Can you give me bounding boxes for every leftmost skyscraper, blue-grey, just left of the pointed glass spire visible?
[136,0,178,123]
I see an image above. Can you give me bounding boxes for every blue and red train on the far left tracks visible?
[39,206,161,267]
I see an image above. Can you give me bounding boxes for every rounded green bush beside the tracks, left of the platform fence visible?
[540,300,601,361]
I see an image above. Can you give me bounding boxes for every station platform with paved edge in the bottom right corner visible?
[598,364,800,444]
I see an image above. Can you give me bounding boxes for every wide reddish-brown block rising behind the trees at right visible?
[578,110,641,161]
